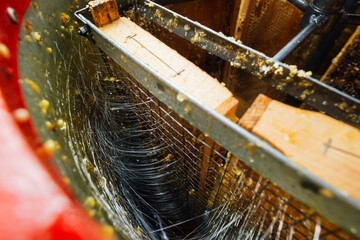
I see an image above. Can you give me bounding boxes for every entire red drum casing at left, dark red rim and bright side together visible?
[0,0,106,239]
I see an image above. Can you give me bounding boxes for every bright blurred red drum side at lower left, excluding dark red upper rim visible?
[0,92,104,240]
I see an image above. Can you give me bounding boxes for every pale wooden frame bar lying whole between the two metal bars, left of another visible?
[100,17,238,118]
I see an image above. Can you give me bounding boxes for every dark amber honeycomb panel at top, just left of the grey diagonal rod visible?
[235,0,303,56]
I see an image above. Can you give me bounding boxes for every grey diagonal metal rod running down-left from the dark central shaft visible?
[273,16,320,62]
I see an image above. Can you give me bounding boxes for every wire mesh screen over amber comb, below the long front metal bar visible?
[102,54,352,239]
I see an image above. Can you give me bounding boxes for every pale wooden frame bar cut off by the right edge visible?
[239,93,360,200]
